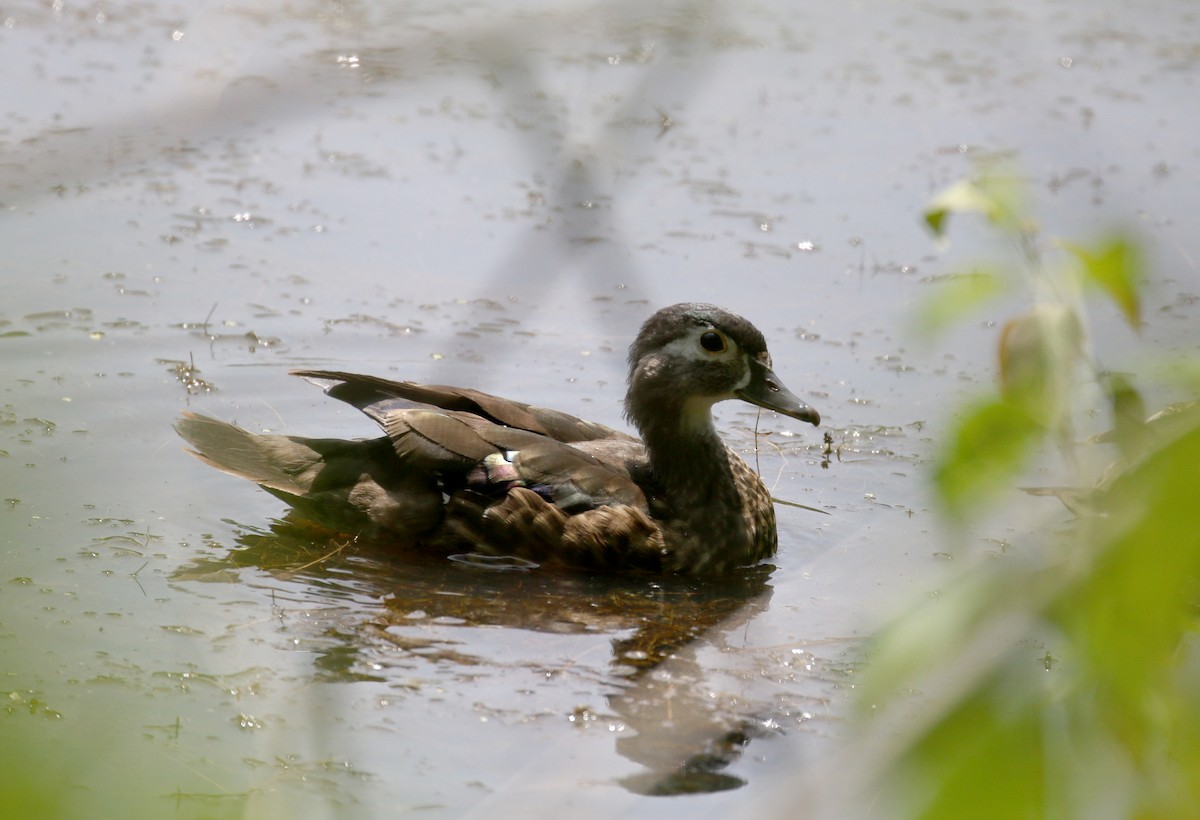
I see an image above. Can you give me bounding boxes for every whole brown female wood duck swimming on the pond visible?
[176,304,821,574]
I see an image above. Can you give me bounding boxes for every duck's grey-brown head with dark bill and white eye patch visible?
[625,303,821,436]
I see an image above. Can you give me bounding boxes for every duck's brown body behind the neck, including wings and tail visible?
[178,371,661,565]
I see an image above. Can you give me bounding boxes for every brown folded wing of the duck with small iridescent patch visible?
[293,370,647,513]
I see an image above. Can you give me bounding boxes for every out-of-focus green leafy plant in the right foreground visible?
[862,169,1200,818]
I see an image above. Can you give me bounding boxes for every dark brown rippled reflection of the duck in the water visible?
[174,521,806,795]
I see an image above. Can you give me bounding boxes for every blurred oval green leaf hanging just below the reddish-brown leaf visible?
[934,399,1043,520]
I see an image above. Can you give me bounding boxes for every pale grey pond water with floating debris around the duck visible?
[0,0,1200,818]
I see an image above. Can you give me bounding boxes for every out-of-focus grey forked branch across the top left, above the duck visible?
[0,0,725,372]
